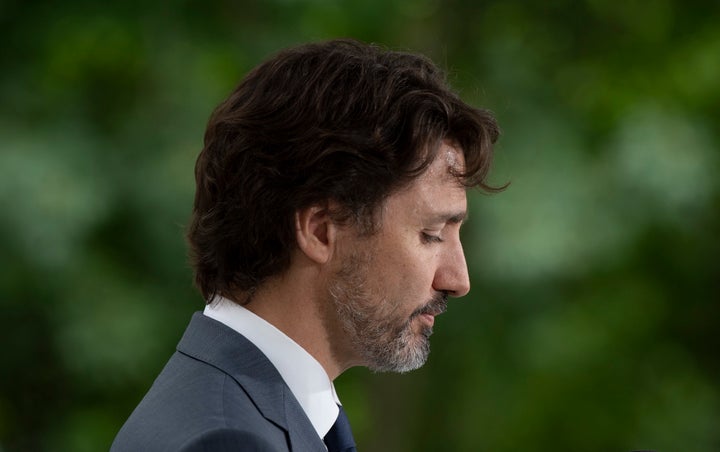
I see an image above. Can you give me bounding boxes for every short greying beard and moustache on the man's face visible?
[329,255,447,373]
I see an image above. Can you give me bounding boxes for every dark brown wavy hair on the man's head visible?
[188,40,499,301]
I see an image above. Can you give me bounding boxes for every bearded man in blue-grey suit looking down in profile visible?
[112,41,498,452]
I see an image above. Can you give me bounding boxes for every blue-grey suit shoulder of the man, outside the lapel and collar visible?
[112,353,287,451]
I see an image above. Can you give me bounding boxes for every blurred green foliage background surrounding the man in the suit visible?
[0,0,720,452]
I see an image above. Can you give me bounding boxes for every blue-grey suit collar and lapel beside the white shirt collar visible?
[177,312,326,451]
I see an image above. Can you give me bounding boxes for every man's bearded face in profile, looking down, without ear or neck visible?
[329,144,470,372]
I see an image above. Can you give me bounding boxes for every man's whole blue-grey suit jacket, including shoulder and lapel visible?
[110,313,326,452]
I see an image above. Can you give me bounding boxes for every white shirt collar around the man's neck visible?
[203,297,340,438]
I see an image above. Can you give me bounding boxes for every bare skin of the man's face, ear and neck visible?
[246,143,470,379]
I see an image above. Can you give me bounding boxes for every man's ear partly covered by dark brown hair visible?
[295,205,337,264]
